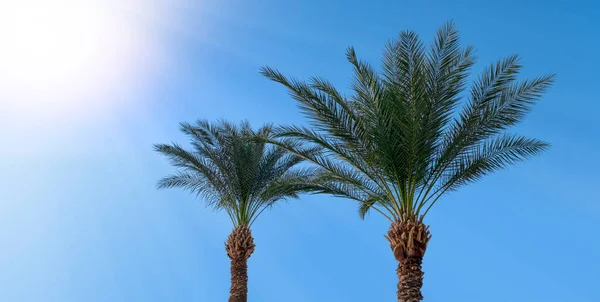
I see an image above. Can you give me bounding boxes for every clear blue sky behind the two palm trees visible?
[0,0,600,302]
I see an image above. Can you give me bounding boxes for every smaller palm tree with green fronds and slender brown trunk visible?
[154,120,312,302]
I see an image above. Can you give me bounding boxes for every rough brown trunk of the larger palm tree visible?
[385,219,431,302]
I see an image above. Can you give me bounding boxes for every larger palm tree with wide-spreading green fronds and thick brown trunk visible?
[262,22,553,302]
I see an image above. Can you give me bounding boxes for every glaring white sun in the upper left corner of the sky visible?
[0,0,164,121]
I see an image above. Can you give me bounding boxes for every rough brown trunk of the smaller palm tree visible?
[225,225,255,302]
